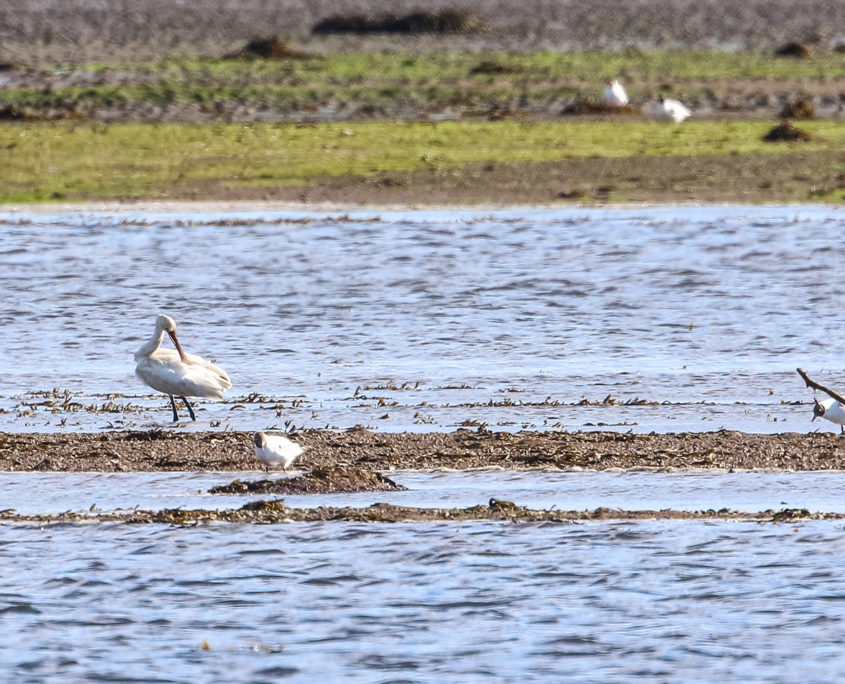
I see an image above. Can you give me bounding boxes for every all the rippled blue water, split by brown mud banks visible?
[0,207,845,683]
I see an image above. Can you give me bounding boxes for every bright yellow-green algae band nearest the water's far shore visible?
[0,121,845,203]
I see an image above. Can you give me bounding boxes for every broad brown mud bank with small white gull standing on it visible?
[0,428,845,472]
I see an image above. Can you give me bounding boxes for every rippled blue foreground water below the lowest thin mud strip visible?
[0,522,845,683]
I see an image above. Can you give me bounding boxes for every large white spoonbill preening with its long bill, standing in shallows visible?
[135,314,232,423]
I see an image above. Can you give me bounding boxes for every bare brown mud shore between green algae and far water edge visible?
[199,150,845,206]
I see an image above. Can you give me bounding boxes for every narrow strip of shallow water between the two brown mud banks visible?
[0,470,845,515]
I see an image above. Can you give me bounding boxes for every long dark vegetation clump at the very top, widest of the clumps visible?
[312,9,484,34]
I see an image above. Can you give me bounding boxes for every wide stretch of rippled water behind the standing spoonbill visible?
[0,207,845,432]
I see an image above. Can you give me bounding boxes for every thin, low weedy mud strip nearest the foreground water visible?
[0,499,832,526]
